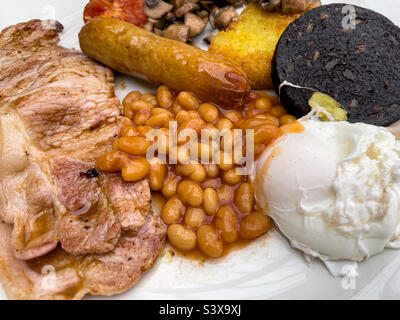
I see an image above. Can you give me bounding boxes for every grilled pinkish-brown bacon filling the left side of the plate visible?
[0,20,166,299]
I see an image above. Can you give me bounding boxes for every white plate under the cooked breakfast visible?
[0,0,400,299]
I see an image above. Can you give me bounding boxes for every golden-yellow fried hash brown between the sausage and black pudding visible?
[209,4,318,89]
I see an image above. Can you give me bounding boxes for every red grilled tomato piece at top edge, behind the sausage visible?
[83,0,148,27]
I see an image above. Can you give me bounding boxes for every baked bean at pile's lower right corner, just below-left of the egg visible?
[239,211,271,239]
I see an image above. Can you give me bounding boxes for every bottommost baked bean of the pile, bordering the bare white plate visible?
[197,225,224,258]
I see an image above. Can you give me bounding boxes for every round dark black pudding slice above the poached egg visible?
[272,4,400,126]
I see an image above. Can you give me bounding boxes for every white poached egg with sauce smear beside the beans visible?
[252,119,400,261]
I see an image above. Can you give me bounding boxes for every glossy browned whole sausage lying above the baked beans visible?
[79,18,250,108]
